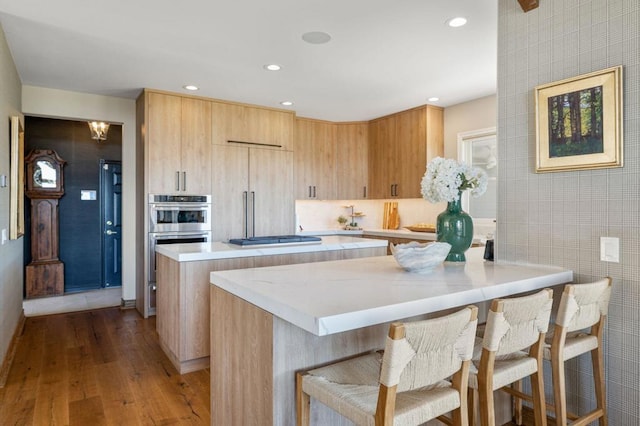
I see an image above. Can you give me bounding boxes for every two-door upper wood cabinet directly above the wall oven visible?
[142,91,211,194]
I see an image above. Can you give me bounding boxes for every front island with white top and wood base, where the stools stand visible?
[211,248,573,425]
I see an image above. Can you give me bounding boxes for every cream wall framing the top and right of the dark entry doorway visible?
[22,86,136,301]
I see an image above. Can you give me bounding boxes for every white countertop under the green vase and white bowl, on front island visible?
[211,248,573,336]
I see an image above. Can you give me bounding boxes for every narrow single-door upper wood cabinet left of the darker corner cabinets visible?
[335,122,369,200]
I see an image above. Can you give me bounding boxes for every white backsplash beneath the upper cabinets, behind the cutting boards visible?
[296,198,495,238]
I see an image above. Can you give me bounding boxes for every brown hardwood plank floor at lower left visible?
[0,308,210,426]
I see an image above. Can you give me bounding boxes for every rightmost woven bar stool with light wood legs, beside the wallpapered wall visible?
[513,277,612,426]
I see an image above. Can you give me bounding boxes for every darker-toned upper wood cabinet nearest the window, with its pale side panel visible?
[368,105,444,199]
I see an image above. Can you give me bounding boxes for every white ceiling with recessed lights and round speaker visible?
[0,0,498,121]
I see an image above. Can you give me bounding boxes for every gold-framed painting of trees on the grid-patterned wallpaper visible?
[535,66,623,173]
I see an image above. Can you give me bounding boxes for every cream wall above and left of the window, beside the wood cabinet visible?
[444,95,497,159]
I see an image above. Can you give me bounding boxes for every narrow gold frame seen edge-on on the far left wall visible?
[9,116,24,240]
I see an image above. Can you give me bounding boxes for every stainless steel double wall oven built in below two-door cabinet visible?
[147,194,212,314]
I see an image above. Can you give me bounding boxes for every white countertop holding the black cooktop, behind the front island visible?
[156,235,387,262]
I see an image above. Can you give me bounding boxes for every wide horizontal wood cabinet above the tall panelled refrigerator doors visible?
[212,101,294,151]
